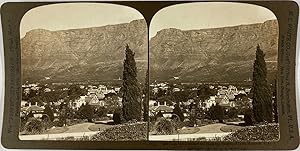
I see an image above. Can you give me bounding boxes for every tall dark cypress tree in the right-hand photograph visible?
[252,45,273,122]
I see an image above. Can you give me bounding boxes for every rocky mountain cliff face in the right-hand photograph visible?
[149,20,279,82]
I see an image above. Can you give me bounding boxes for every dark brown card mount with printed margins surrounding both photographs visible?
[1,1,299,149]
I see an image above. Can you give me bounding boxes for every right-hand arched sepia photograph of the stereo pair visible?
[149,2,280,142]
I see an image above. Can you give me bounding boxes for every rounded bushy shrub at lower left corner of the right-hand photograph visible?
[155,118,175,135]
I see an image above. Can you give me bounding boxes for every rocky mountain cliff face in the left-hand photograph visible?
[21,20,148,82]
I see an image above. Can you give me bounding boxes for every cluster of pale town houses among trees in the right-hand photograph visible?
[149,82,252,116]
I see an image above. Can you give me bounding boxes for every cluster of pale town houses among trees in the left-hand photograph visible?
[20,84,122,118]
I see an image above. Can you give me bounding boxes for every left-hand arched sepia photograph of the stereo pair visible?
[19,3,148,141]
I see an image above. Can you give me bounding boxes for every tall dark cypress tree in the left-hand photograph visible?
[122,45,141,121]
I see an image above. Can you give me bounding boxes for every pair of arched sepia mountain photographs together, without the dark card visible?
[19,2,280,142]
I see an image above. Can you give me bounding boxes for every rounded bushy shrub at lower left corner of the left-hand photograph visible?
[24,117,45,134]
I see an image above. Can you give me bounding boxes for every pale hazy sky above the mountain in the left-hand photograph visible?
[20,3,143,37]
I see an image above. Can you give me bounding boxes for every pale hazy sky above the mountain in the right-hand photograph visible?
[149,2,276,37]
